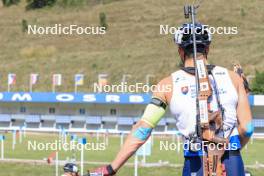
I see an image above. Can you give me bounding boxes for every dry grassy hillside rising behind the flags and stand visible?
[0,0,264,91]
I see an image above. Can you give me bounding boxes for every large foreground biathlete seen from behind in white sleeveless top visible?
[91,23,254,176]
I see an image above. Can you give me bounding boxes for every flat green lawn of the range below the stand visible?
[0,134,264,176]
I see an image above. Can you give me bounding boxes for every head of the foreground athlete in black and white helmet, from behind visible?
[174,23,211,62]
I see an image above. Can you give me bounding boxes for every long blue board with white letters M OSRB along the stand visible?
[0,92,264,106]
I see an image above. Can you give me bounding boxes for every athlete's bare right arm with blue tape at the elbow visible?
[230,73,254,147]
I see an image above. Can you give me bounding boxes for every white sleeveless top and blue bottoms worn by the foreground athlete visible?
[170,66,245,176]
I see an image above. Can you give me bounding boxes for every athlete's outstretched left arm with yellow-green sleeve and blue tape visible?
[93,78,173,175]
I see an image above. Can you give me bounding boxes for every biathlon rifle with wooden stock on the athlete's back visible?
[184,2,228,176]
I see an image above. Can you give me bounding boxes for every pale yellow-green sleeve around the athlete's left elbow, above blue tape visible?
[142,104,165,128]
